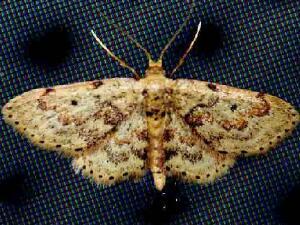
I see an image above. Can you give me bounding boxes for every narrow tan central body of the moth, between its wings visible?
[143,85,166,190]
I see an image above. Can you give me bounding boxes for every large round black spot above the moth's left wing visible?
[25,26,72,67]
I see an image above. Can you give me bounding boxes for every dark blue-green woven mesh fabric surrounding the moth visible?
[0,0,300,225]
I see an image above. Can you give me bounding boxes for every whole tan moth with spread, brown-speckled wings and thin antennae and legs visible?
[2,14,299,190]
